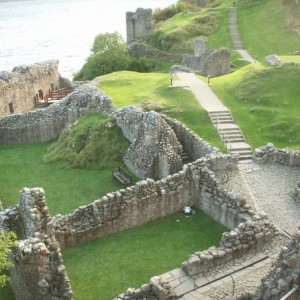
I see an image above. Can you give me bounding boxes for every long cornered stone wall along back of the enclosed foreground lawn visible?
[52,155,255,248]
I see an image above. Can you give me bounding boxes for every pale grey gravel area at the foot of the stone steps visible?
[226,162,300,235]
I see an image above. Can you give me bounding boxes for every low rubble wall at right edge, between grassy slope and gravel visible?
[254,143,300,167]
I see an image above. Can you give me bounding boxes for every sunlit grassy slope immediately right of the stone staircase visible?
[212,63,300,149]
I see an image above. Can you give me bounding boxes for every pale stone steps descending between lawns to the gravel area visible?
[209,110,253,161]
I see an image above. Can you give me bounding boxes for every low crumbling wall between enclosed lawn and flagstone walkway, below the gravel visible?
[182,219,277,276]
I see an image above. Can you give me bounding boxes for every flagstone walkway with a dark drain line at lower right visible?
[160,236,287,300]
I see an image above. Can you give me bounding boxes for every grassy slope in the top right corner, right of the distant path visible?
[238,0,300,61]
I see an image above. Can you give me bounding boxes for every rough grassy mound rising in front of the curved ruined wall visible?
[44,114,130,169]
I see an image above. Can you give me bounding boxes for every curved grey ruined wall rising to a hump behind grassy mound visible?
[0,84,115,144]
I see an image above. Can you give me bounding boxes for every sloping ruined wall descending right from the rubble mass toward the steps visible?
[164,116,219,161]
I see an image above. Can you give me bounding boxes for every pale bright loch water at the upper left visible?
[0,0,177,79]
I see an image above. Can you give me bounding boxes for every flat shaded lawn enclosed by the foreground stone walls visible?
[63,211,226,300]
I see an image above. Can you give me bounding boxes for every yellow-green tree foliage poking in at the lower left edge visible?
[0,232,16,288]
